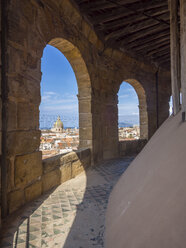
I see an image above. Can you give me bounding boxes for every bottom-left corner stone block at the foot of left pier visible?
[8,190,25,214]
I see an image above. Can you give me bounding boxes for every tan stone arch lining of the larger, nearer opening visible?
[48,38,92,148]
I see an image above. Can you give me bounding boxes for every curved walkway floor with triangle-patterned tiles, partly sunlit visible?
[0,157,133,248]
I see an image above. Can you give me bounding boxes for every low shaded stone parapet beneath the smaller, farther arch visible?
[119,139,147,157]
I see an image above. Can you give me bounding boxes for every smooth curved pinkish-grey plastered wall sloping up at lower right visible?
[105,113,186,248]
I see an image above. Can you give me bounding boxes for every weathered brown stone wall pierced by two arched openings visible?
[0,0,170,217]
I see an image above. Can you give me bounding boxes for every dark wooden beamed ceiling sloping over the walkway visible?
[73,0,173,68]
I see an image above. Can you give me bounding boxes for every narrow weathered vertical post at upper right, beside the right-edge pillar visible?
[169,0,180,115]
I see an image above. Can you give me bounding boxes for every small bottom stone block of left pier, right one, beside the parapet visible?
[25,181,42,202]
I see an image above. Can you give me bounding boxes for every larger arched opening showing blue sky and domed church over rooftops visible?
[40,45,79,159]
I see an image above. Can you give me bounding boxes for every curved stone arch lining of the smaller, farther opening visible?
[118,79,149,139]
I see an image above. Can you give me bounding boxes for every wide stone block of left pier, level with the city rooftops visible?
[7,130,41,155]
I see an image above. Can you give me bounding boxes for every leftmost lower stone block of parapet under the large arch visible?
[42,169,61,193]
